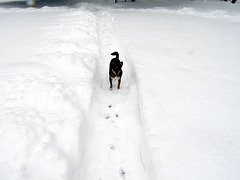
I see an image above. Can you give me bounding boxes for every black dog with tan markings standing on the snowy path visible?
[109,52,123,89]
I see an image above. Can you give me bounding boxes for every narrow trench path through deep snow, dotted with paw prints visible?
[80,6,150,180]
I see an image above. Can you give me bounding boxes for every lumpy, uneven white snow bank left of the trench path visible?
[0,5,98,180]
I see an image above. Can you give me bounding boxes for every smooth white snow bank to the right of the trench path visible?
[111,2,240,179]
